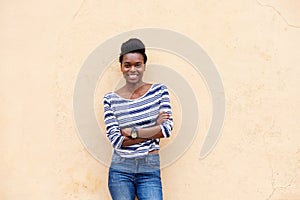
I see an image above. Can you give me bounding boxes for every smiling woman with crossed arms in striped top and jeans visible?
[104,38,173,200]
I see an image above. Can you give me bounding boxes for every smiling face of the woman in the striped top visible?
[121,53,145,84]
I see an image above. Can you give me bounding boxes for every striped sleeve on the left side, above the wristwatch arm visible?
[103,94,125,149]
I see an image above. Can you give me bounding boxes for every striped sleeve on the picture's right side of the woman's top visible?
[159,85,173,138]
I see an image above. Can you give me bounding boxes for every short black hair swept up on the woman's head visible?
[119,38,147,64]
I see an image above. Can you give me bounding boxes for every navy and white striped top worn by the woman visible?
[104,83,173,158]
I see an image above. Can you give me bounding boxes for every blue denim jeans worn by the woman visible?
[108,153,163,200]
